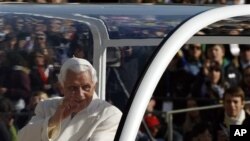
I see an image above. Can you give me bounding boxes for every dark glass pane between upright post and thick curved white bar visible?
[106,46,156,111]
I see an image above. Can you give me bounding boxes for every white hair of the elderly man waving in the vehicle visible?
[58,57,97,85]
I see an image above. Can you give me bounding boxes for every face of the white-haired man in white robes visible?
[63,70,95,108]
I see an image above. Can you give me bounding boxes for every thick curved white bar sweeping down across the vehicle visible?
[120,5,250,141]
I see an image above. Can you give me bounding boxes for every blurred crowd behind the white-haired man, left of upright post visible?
[0,14,94,141]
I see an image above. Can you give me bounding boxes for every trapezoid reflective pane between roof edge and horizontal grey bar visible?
[93,15,188,39]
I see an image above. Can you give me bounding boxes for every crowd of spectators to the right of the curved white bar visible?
[138,40,250,141]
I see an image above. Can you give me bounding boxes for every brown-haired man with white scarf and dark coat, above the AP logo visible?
[215,87,250,141]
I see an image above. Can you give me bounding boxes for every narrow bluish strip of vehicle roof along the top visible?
[0,3,215,17]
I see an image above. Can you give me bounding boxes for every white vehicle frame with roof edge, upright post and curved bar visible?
[0,4,250,141]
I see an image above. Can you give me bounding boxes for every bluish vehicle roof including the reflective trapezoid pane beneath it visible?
[0,3,215,39]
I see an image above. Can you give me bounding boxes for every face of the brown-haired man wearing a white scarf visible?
[224,95,244,118]
